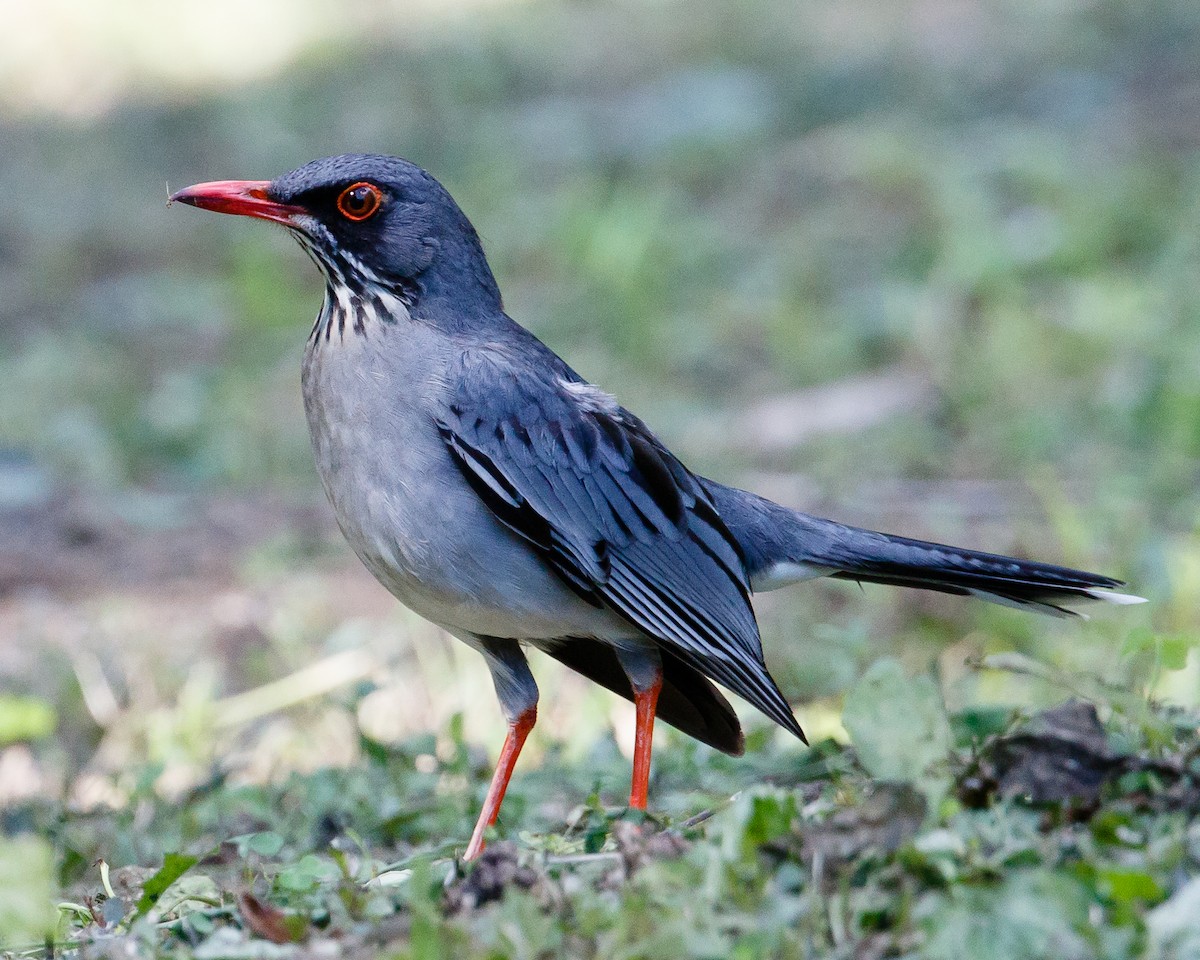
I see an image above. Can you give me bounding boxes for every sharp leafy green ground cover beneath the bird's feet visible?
[7,661,1200,958]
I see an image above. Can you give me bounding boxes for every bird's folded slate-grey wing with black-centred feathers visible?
[438,348,804,738]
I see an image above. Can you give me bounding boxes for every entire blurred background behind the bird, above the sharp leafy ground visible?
[0,0,1200,825]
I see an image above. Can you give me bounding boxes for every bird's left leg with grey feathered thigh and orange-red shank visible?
[464,637,538,860]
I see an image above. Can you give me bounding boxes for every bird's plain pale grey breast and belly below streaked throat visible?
[302,326,630,641]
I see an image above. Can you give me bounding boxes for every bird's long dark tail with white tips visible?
[704,480,1145,617]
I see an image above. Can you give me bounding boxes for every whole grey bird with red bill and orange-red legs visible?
[169,154,1142,860]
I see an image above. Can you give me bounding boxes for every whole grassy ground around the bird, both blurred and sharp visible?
[0,0,1200,960]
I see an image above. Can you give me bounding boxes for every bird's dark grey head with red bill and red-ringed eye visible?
[170,154,500,323]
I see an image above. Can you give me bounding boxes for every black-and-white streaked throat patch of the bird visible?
[292,230,414,343]
